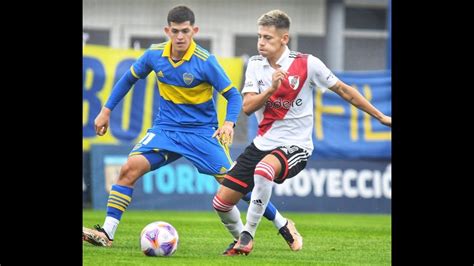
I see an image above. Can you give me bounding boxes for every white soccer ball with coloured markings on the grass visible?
[140,221,179,257]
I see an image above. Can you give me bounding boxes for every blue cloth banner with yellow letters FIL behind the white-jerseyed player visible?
[248,71,392,159]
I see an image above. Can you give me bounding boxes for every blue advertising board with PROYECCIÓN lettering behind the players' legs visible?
[91,145,391,213]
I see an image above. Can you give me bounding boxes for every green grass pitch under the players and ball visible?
[83,210,392,266]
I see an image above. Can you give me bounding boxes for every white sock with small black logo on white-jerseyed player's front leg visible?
[244,175,273,237]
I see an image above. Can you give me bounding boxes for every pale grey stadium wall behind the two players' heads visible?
[83,0,326,57]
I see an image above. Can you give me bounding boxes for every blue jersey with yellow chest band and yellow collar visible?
[131,41,232,132]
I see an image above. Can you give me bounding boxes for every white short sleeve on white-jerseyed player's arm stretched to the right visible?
[308,55,339,92]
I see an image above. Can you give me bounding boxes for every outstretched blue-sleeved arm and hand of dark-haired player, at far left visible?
[94,51,151,136]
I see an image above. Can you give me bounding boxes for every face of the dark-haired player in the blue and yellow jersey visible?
[165,21,198,53]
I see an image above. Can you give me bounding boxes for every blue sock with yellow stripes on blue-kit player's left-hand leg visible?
[107,185,133,221]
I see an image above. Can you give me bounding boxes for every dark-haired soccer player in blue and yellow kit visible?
[83,6,300,252]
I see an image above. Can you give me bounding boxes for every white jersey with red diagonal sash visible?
[242,47,338,154]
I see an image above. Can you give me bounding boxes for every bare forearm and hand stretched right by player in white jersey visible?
[329,80,392,127]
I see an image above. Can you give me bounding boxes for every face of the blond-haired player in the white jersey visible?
[257,26,289,58]
